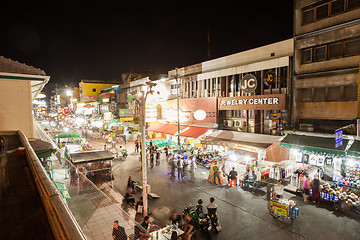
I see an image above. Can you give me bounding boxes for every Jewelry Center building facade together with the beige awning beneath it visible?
[168,39,294,161]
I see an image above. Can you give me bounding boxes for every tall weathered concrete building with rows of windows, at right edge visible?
[292,0,360,133]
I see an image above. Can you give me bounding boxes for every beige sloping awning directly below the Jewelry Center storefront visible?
[205,130,280,148]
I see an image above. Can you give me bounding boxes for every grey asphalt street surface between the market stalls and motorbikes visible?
[109,142,360,240]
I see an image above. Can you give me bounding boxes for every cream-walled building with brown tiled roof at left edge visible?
[0,57,50,138]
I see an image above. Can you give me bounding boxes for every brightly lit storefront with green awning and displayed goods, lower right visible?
[271,134,360,208]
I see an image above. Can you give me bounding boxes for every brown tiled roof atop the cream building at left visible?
[0,56,46,76]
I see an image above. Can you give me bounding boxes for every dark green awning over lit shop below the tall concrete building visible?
[280,134,349,155]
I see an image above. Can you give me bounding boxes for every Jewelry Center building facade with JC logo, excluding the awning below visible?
[169,39,293,134]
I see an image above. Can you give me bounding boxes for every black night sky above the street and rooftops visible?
[0,0,293,91]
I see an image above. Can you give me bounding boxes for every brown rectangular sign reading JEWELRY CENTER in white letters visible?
[218,94,286,110]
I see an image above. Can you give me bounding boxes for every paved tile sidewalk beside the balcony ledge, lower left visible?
[53,156,136,240]
